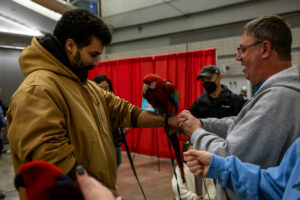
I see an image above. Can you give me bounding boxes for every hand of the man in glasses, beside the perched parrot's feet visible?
[176,110,202,137]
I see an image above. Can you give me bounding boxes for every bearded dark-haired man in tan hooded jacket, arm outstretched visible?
[7,9,175,198]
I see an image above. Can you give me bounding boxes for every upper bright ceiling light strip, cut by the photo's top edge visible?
[12,0,61,21]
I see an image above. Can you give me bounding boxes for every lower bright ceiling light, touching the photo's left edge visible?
[0,15,43,36]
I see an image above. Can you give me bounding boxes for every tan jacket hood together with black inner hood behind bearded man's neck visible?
[19,35,80,82]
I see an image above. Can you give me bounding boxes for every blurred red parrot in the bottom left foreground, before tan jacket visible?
[15,161,83,200]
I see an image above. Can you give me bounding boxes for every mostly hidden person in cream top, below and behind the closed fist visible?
[172,141,216,200]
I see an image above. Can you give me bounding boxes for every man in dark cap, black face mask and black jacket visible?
[189,65,245,118]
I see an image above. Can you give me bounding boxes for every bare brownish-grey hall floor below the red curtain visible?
[0,146,174,200]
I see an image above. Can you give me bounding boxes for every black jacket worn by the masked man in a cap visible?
[189,85,246,119]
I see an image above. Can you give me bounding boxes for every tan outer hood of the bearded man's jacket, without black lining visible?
[19,37,80,82]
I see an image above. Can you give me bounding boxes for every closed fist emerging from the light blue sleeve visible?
[183,150,212,177]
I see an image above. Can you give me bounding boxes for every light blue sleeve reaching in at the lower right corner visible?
[207,139,300,200]
